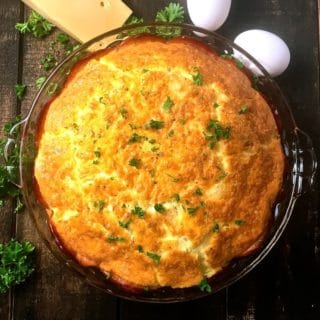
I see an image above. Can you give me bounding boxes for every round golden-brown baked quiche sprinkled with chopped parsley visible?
[35,36,284,288]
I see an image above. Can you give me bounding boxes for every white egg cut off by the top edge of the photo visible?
[187,0,231,31]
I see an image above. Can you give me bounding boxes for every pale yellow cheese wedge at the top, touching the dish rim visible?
[22,0,132,42]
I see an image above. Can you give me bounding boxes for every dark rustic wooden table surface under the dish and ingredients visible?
[0,0,320,320]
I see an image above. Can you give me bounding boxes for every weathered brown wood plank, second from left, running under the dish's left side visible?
[14,9,117,320]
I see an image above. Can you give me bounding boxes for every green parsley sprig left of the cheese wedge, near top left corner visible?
[15,11,54,38]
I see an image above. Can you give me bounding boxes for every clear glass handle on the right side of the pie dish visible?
[296,128,318,196]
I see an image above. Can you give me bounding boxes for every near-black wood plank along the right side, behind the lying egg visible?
[225,0,320,319]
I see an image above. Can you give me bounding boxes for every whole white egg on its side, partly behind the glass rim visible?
[233,29,290,77]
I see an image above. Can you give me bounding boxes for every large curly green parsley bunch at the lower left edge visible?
[0,239,35,294]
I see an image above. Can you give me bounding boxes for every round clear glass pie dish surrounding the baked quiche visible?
[7,23,317,303]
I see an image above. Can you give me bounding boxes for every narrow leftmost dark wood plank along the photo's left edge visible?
[0,0,20,319]
